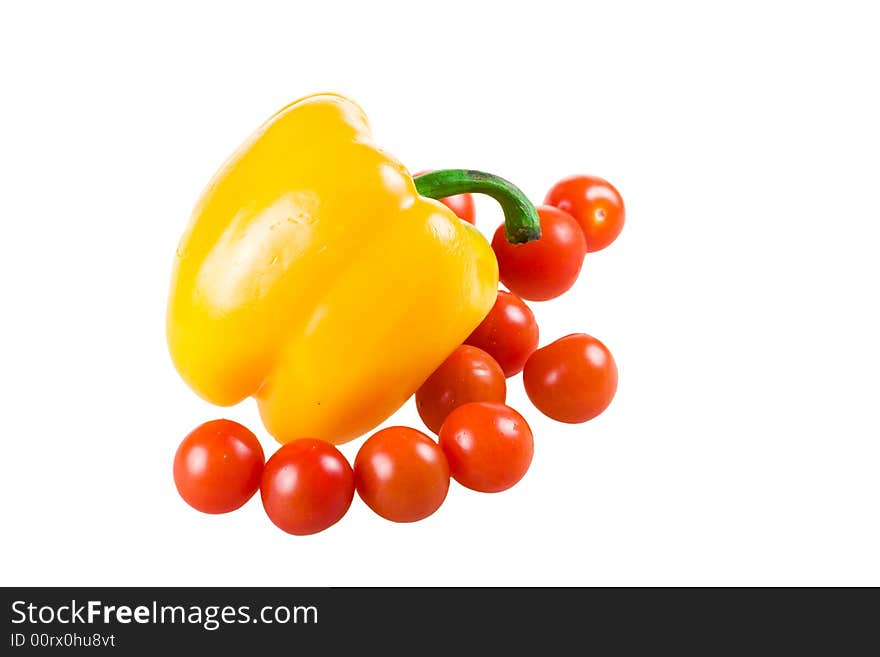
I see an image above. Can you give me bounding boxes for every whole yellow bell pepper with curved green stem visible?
[167,94,540,443]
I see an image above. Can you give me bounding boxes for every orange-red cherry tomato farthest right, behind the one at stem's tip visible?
[544,176,626,252]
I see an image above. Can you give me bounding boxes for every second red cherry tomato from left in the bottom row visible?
[260,438,354,536]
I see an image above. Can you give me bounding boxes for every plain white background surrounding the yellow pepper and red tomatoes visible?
[0,0,880,586]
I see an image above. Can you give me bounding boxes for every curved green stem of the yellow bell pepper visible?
[414,169,541,244]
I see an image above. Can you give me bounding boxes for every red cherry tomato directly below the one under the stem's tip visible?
[464,290,538,376]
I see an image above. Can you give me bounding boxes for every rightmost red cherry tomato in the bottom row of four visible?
[440,402,534,493]
